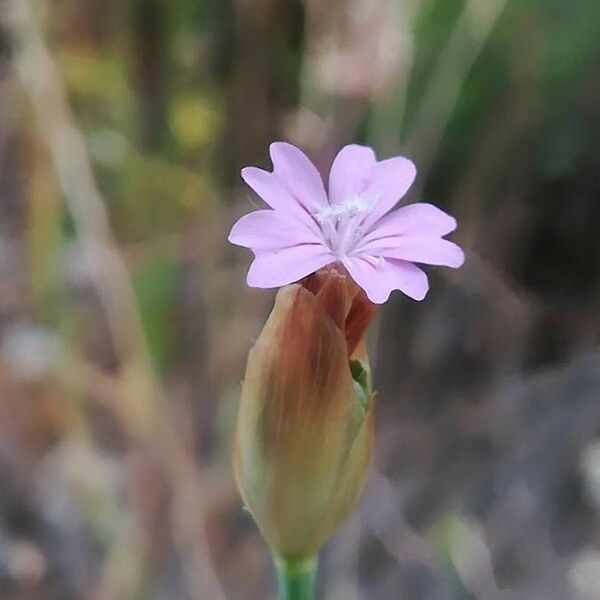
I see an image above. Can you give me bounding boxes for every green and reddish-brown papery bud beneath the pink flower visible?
[234,267,375,559]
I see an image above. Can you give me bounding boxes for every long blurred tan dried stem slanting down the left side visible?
[5,0,224,600]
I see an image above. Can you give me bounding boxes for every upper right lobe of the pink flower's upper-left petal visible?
[269,142,327,214]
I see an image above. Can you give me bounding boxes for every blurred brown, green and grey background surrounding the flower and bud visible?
[0,0,600,600]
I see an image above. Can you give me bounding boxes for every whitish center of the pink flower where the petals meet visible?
[315,194,376,258]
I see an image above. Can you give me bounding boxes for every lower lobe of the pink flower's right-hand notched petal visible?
[355,235,465,269]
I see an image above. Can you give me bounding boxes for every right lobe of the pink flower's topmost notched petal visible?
[364,156,417,228]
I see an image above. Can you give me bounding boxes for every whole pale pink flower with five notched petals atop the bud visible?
[229,142,464,304]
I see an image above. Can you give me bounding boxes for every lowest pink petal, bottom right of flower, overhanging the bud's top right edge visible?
[344,256,429,304]
